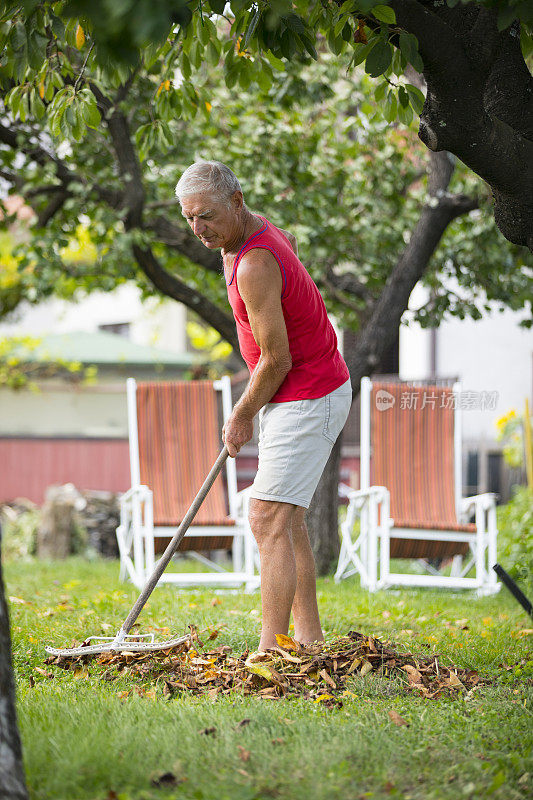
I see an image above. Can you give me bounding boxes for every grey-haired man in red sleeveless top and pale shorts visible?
[176,161,352,650]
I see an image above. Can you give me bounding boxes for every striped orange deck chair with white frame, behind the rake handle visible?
[117,376,259,590]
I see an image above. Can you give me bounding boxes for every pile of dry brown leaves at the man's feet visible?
[46,626,488,707]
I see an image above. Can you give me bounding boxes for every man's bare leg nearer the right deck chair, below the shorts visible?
[292,506,324,644]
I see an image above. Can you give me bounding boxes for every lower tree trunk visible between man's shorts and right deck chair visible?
[306,433,342,575]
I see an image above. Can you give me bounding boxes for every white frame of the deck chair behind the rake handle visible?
[116,375,260,591]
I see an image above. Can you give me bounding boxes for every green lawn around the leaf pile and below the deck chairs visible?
[5,559,533,800]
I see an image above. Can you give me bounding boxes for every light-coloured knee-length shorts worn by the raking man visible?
[250,380,352,508]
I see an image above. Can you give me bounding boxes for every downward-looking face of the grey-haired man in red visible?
[181,192,242,250]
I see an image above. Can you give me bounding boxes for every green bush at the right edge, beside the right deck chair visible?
[498,486,533,592]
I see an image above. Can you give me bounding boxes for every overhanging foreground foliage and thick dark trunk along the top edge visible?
[0,0,533,249]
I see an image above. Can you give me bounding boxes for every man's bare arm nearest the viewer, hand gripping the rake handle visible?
[223,249,292,456]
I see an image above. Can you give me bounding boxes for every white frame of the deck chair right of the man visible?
[335,378,501,594]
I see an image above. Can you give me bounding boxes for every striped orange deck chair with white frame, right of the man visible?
[335,378,500,594]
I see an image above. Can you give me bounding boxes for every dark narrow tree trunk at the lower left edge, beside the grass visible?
[0,528,28,800]
